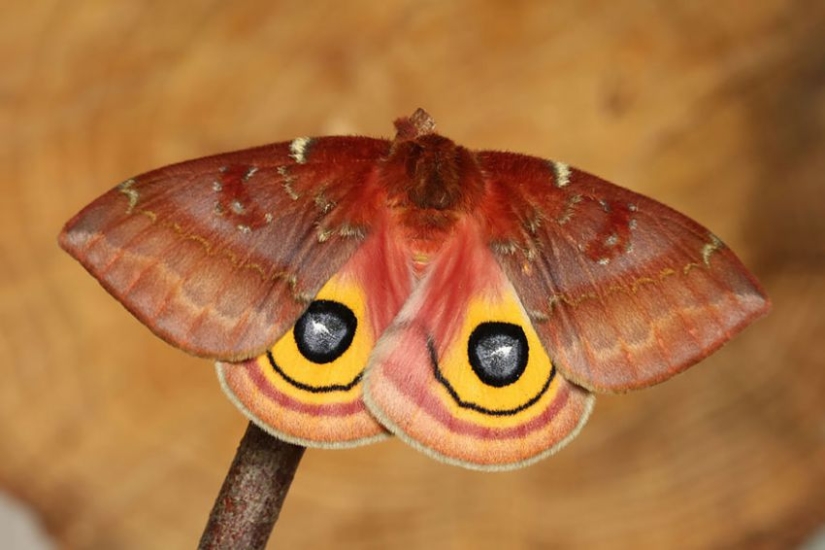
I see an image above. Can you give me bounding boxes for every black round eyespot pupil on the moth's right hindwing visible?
[467,322,528,388]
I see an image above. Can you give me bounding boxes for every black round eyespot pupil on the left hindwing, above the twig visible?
[293,300,358,363]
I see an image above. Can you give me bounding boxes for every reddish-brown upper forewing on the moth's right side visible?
[478,152,769,392]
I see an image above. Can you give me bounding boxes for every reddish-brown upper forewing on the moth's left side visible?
[60,137,389,361]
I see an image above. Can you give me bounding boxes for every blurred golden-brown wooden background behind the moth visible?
[0,0,825,549]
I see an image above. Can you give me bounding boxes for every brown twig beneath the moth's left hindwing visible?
[198,422,305,550]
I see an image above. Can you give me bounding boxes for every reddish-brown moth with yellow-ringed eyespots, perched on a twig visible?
[60,109,769,470]
